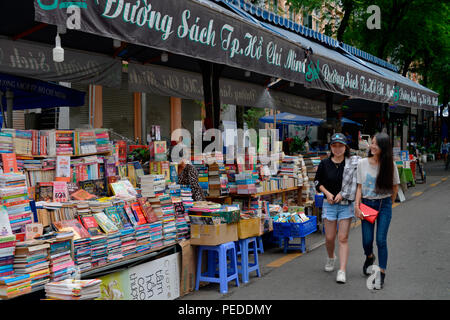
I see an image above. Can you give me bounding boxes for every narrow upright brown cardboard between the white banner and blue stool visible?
[179,240,197,297]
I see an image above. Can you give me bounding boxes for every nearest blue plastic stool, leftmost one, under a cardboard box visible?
[195,242,239,294]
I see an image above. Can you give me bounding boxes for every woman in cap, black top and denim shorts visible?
[314,133,354,283]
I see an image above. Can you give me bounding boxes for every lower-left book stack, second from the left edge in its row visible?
[14,240,50,288]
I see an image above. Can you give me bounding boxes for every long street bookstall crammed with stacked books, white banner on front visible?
[0,124,336,300]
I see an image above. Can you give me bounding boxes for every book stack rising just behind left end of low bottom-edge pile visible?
[49,238,75,281]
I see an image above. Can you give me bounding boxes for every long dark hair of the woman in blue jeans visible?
[369,132,395,194]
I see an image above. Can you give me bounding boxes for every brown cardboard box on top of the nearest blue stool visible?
[191,223,238,246]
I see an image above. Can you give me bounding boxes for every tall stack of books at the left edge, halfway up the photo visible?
[0,173,32,233]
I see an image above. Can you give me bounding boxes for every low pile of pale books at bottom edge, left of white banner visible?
[45,279,102,300]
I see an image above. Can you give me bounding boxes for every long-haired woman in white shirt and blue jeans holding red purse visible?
[355,133,400,287]
